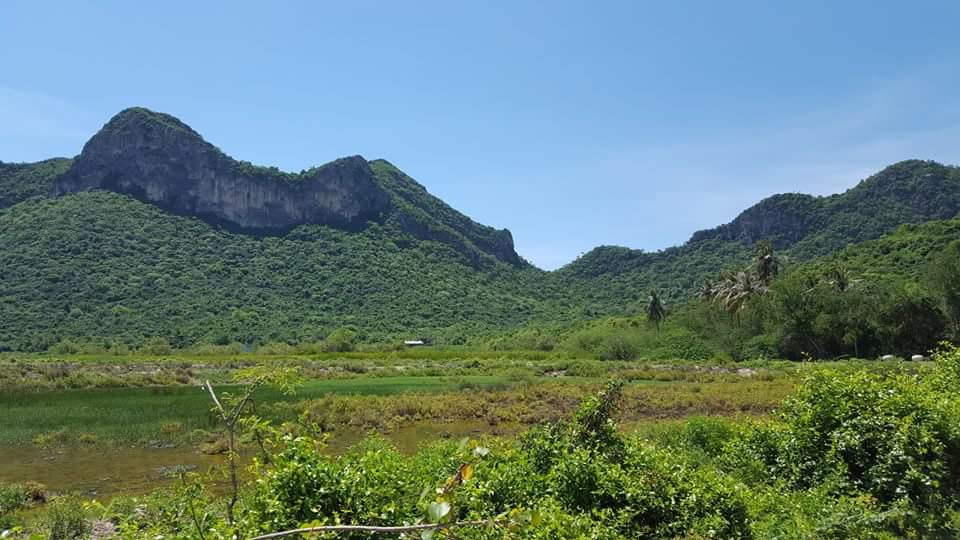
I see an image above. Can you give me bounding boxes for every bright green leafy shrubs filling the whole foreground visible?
[7,348,960,540]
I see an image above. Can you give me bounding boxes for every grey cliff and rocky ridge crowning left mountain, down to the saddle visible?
[51,107,527,266]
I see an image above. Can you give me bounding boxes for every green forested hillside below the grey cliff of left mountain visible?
[0,192,561,349]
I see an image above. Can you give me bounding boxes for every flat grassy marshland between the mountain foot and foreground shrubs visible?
[0,351,924,445]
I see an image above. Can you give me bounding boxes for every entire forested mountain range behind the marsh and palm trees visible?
[0,108,960,350]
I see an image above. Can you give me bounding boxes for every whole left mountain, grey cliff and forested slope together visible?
[0,108,540,350]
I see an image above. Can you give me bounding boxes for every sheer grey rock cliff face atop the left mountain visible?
[53,108,390,229]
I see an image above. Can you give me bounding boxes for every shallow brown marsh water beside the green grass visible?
[0,421,520,498]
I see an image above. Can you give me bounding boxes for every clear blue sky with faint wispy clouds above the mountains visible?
[0,0,960,268]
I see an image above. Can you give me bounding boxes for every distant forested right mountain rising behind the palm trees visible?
[558,160,960,306]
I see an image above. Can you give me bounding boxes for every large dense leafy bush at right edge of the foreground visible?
[720,358,960,536]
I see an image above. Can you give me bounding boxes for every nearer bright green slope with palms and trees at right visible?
[498,219,960,360]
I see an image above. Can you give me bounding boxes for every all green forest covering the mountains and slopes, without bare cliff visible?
[0,108,960,359]
